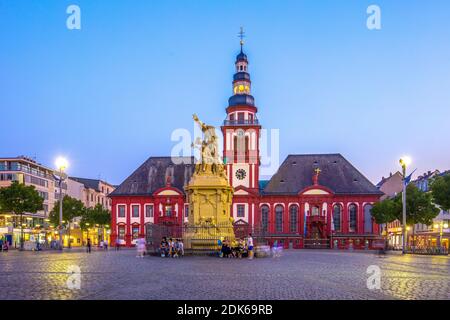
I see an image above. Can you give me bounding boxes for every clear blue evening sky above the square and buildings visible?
[0,0,450,183]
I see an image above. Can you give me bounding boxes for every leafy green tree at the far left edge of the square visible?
[0,181,44,250]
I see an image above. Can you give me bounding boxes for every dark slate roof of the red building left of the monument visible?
[110,157,195,196]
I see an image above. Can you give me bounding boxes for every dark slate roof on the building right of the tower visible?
[262,154,383,195]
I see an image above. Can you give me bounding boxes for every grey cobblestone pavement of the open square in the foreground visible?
[0,250,450,300]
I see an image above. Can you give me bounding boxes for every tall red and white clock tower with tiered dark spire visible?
[221,29,261,189]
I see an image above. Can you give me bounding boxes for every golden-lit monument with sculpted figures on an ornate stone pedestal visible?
[184,114,235,250]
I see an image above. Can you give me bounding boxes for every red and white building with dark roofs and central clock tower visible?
[109,43,383,249]
